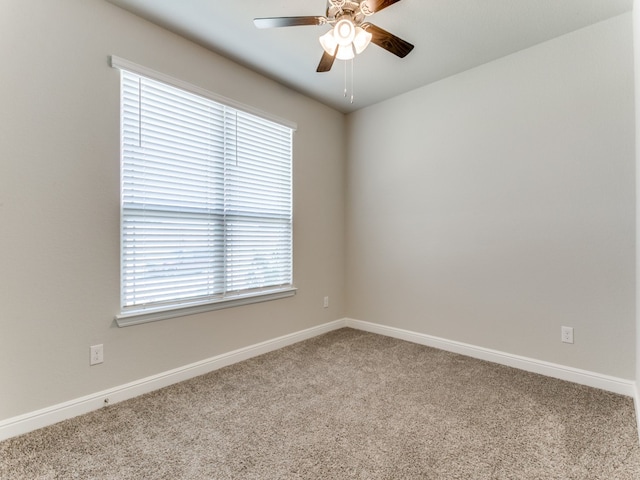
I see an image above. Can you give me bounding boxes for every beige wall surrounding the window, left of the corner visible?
[0,0,345,420]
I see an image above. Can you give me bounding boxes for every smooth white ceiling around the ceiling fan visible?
[108,0,633,113]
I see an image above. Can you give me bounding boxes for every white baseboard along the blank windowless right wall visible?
[345,318,638,398]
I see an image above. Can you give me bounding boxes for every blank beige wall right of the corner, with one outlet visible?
[347,13,635,379]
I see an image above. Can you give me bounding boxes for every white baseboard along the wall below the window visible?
[0,320,346,441]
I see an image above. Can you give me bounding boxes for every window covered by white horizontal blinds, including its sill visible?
[112,60,295,325]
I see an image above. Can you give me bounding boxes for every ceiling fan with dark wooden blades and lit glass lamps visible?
[253,0,413,72]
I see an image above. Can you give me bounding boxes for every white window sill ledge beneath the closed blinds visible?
[115,287,297,327]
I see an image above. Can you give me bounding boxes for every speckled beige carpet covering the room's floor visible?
[0,329,640,480]
